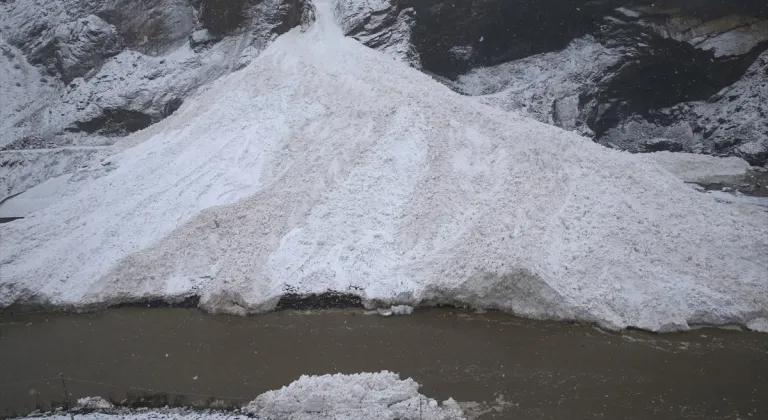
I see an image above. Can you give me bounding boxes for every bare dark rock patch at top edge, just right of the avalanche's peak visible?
[403,0,617,78]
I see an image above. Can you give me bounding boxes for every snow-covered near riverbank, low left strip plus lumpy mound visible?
[28,371,465,420]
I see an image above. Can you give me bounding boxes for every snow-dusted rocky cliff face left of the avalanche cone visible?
[0,0,313,201]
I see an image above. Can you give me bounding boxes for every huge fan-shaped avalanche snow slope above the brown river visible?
[0,1,768,330]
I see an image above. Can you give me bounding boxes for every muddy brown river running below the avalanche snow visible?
[0,307,768,419]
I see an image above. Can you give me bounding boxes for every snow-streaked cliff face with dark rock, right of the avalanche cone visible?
[337,0,768,165]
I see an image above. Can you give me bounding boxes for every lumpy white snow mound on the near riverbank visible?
[244,371,464,420]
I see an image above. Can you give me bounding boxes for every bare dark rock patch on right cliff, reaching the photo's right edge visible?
[580,22,768,138]
